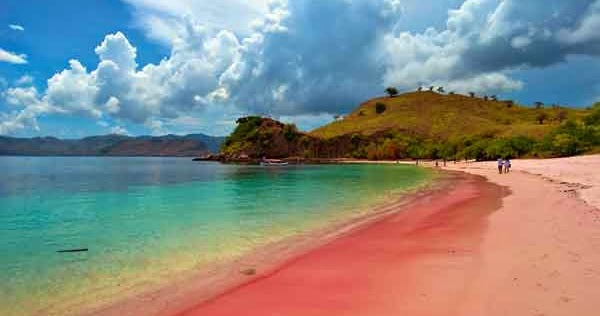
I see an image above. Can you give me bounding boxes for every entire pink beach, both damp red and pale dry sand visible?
[171,156,600,316]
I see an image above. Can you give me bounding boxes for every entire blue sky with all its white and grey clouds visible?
[0,0,600,138]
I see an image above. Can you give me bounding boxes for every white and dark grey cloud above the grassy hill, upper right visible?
[384,0,600,93]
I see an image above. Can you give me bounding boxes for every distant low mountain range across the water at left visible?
[0,134,225,157]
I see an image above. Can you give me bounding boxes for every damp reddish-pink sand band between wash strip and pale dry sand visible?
[178,176,507,316]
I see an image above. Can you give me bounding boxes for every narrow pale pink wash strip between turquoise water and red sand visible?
[82,167,450,316]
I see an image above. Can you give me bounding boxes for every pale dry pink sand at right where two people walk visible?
[440,156,600,315]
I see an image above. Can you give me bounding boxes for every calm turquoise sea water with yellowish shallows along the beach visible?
[0,157,432,316]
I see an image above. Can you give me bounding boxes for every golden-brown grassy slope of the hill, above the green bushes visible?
[310,91,588,140]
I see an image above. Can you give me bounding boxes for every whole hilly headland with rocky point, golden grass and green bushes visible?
[220,89,600,161]
